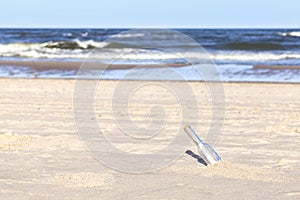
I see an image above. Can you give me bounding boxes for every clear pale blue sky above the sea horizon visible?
[0,0,300,28]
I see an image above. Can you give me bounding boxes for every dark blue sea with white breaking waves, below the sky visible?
[0,29,300,83]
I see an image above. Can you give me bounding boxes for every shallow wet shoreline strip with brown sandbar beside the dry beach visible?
[0,60,300,84]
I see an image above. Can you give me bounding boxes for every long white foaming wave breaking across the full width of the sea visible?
[0,40,300,64]
